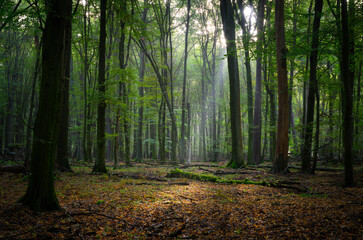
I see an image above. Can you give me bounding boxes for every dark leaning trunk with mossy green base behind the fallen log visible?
[220,0,245,168]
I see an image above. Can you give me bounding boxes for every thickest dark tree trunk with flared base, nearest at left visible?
[19,0,72,211]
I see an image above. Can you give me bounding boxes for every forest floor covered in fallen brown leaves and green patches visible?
[0,162,363,239]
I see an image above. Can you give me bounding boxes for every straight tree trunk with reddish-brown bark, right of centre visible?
[271,0,289,173]
